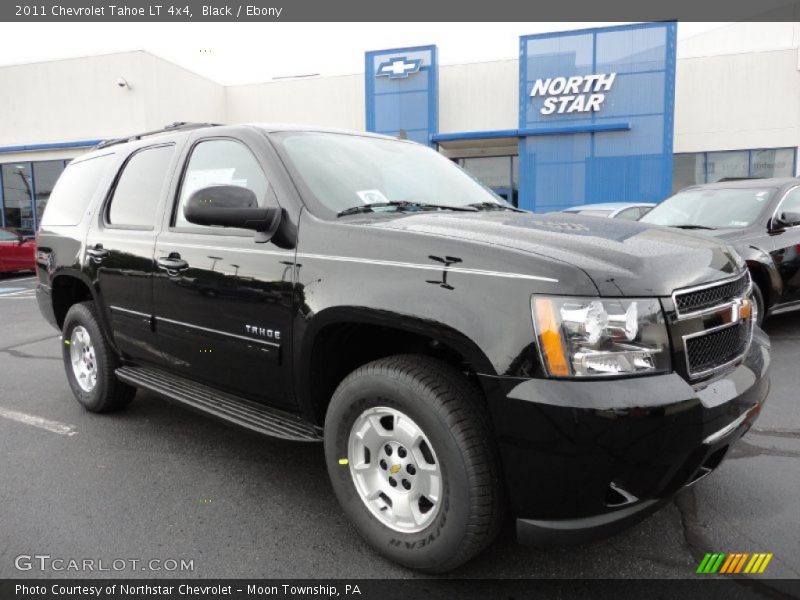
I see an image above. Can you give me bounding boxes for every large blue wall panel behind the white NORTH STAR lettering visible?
[519,23,677,212]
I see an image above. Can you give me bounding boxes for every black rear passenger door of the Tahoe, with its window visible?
[85,143,177,363]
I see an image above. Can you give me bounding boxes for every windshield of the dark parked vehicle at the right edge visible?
[639,188,775,229]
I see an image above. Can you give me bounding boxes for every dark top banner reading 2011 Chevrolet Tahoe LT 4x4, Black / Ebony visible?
[0,0,800,23]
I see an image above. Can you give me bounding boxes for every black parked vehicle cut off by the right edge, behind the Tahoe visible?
[641,178,800,325]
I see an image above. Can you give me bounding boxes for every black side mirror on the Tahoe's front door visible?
[183,185,281,242]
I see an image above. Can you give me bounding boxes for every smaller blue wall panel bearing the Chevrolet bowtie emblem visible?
[364,46,439,144]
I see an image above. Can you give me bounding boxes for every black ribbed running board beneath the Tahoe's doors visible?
[116,367,322,442]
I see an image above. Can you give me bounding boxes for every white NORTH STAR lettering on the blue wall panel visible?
[531,73,617,115]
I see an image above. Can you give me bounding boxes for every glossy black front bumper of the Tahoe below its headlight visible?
[484,329,769,543]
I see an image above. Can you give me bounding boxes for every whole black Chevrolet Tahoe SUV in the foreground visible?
[37,124,769,572]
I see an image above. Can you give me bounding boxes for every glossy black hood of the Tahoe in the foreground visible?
[366,211,743,296]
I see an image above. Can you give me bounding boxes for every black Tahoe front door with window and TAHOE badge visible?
[154,137,294,406]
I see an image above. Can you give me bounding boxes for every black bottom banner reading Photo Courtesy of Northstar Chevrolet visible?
[0,577,800,600]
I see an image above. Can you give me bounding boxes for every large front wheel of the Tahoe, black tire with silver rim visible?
[325,355,503,573]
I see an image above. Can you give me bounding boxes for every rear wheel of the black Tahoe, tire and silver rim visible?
[61,302,136,413]
